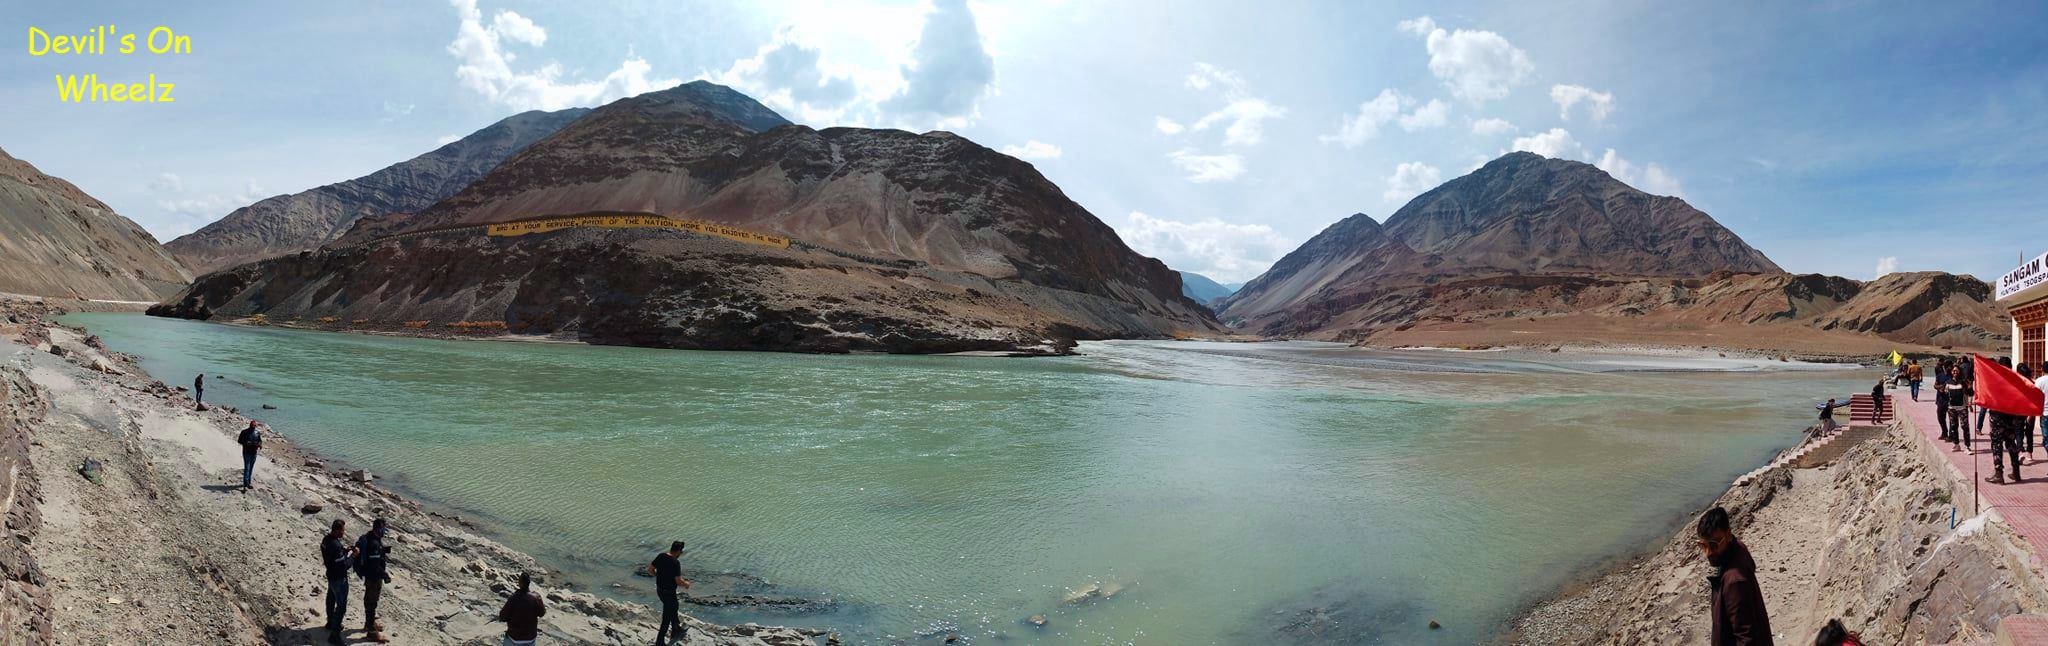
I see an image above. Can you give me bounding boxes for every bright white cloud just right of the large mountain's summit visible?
[711,27,860,125]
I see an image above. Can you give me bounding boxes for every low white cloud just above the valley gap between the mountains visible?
[1116,211,1294,283]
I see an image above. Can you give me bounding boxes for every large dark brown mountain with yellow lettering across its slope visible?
[154,82,1223,353]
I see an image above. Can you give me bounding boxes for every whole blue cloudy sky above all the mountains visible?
[0,0,2048,283]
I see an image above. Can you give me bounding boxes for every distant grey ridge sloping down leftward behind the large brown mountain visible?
[164,109,588,273]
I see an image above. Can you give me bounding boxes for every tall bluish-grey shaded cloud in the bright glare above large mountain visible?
[881,0,995,127]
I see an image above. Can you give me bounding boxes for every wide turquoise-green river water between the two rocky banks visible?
[56,314,1870,644]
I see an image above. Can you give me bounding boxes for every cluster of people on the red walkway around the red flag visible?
[1915,357,2048,484]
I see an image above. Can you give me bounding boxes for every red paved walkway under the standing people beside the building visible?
[1890,392,2048,568]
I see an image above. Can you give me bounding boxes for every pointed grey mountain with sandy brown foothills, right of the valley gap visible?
[1219,152,2007,353]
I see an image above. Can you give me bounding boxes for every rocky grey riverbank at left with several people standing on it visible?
[0,301,838,646]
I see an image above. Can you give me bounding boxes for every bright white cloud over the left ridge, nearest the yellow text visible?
[449,0,678,111]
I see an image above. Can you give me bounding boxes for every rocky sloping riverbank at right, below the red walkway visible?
[1503,406,2048,644]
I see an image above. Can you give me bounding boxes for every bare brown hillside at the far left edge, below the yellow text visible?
[0,150,193,301]
